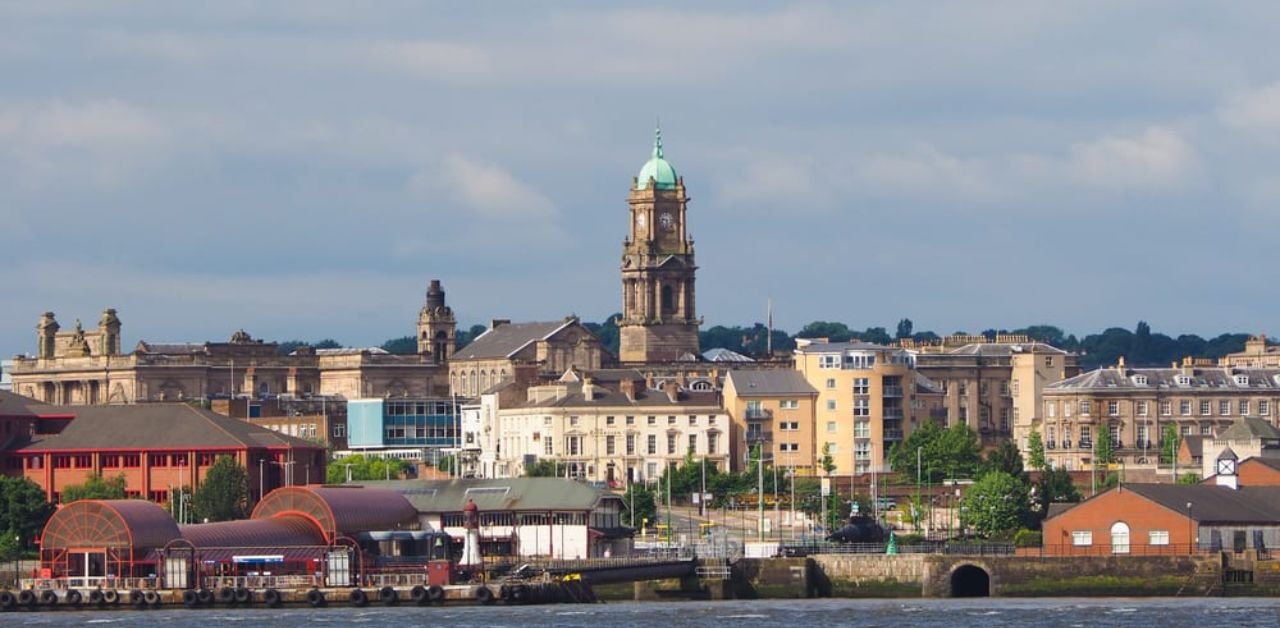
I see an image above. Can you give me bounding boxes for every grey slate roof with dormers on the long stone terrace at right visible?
[1044,367,1280,391]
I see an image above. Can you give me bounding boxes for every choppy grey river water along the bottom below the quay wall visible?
[15,599,1280,628]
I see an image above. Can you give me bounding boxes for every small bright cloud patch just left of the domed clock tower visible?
[408,155,559,221]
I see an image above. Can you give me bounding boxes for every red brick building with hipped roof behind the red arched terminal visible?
[0,395,326,503]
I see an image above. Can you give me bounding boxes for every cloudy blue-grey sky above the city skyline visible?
[0,0,1280,356]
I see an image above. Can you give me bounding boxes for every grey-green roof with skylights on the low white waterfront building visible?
[361,477,613,513]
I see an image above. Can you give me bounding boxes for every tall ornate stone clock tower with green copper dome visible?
[618,129,701,363]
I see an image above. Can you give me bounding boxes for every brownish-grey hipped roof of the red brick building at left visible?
[24,403,321,451]
